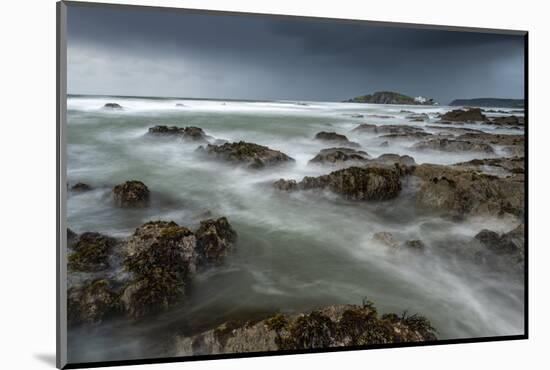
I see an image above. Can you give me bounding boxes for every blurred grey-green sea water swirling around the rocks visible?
[67,96,523,362]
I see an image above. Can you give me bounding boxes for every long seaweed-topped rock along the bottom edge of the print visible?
[174,303,437,356]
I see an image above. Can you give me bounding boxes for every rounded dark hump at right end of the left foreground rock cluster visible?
[195,217,237,264]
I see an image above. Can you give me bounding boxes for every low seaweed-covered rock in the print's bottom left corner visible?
[67,279,119,325]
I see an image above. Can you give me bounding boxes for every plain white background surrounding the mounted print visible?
[0,0,550,370]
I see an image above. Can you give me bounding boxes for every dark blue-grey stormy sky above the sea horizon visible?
[67,5,524,104]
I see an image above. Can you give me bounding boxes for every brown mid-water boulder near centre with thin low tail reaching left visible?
[274,167,401,201]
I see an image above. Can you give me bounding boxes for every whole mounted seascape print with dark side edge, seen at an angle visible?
[58,1,528,368]
